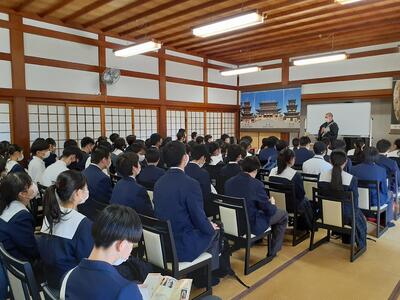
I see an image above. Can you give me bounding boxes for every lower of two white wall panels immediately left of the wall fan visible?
[25,64,100,95]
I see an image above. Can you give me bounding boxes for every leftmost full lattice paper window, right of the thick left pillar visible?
[28,104,67,155]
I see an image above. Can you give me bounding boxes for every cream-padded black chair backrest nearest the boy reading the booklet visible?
[139,215,178,272]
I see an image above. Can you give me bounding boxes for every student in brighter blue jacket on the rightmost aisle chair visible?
[351,147,394,227]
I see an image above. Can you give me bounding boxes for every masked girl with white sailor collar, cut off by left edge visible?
[0,172,39,262]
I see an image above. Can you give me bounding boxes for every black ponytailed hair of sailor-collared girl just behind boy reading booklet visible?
[43,170,86,234]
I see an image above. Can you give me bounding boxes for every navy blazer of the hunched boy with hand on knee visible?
[224,172,276,235]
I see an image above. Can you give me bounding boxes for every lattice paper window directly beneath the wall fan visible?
[104,107,133,138]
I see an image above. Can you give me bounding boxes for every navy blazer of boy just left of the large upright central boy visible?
[111,177,154,216]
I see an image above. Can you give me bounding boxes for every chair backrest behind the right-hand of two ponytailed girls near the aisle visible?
[313,188,355,228]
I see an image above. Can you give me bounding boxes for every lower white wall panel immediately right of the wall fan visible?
[107,76,159,99]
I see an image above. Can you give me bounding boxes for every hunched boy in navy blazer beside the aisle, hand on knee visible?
[224,157,288,256]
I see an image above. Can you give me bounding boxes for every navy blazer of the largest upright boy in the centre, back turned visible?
[154,168,215,262]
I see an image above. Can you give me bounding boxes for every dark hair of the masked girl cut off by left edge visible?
[0,172,32,215]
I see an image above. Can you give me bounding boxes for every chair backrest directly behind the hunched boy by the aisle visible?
[211,194,251,237]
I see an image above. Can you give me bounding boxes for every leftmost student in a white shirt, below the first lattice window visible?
[28,138,50,183]
